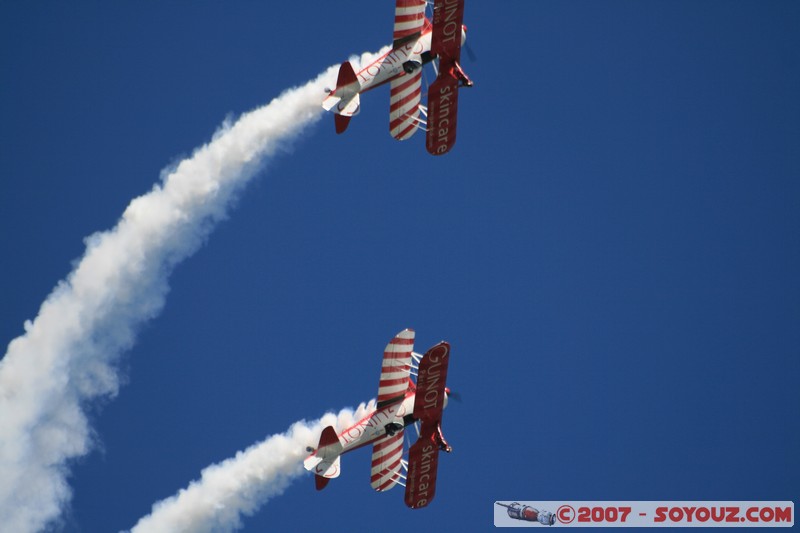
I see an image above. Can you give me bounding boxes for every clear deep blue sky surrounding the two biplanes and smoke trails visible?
[0,1,800,532]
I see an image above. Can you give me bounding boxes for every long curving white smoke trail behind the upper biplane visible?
[0,54,382,533]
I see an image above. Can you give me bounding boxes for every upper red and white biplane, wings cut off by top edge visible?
[322,0,473,155]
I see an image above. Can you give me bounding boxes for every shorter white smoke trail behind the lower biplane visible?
[131,401,375,533]
